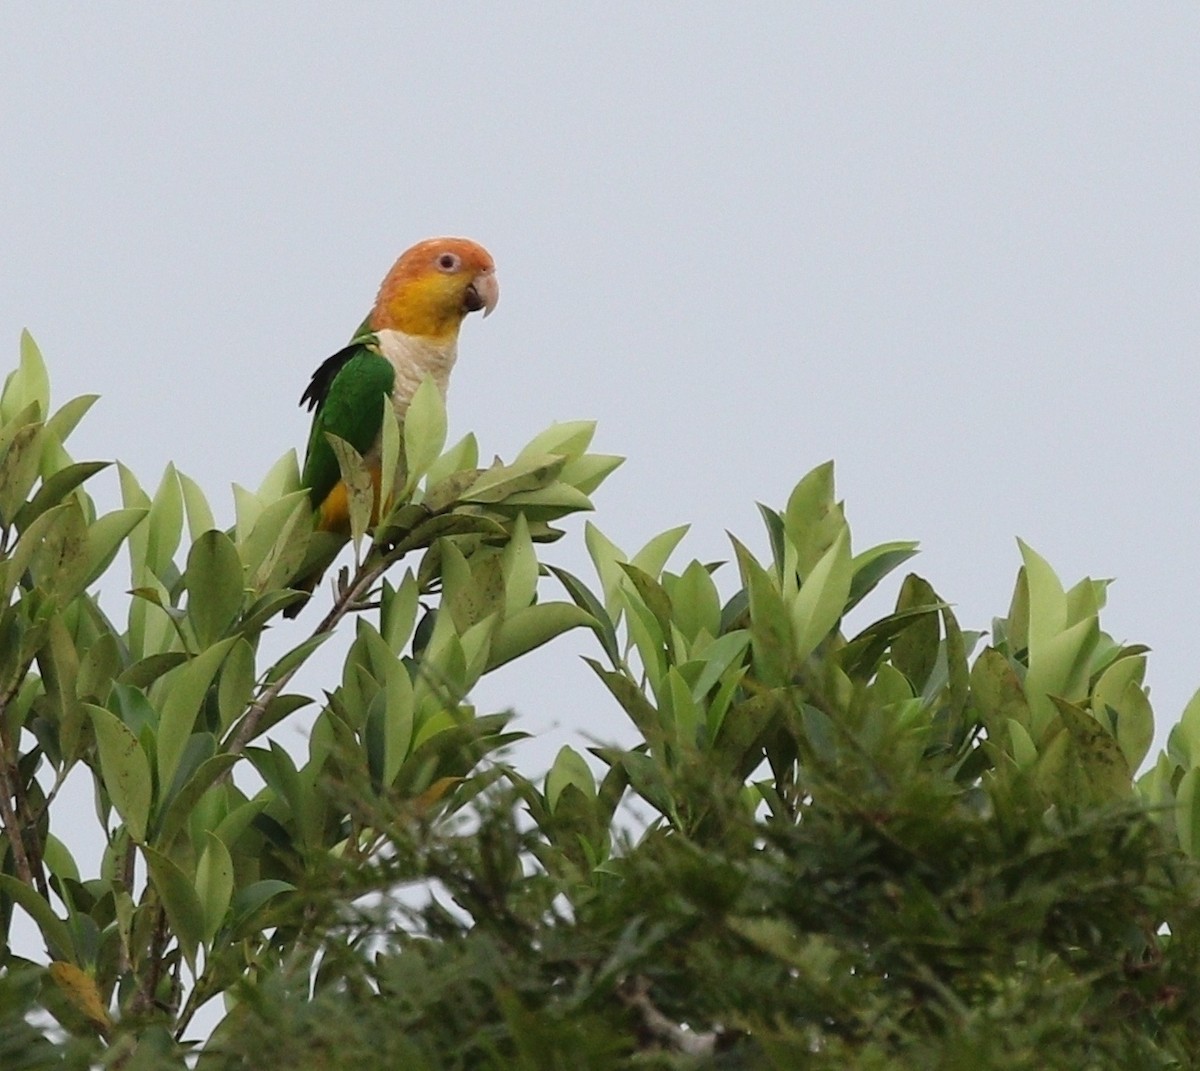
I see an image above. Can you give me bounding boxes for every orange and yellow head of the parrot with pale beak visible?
[368,238,500,342]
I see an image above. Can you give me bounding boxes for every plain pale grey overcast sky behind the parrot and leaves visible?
[0,2,1200,797]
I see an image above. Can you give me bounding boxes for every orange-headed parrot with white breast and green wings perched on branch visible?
[283,238,500,617]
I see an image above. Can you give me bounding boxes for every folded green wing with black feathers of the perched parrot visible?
[300,335,396,508]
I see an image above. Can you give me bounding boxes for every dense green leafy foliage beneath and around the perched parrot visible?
[0,335,1200,1071]
